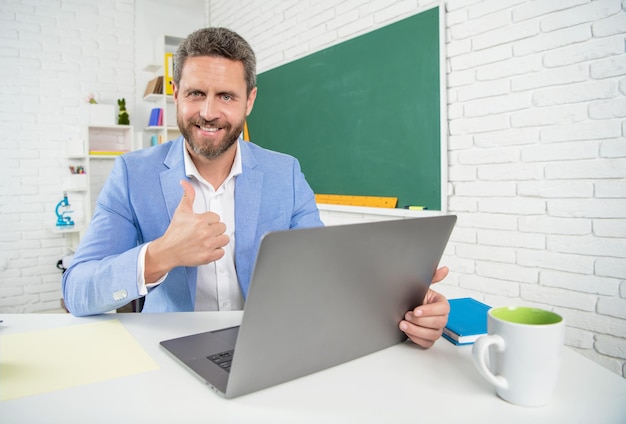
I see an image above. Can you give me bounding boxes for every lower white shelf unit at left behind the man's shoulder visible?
[52,125,136,252]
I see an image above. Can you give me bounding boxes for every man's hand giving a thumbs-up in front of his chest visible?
[145,180,230,284]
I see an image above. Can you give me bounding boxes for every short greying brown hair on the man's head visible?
[174,28,256,94]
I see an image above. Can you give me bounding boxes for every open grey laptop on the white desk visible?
[160,215,456,398]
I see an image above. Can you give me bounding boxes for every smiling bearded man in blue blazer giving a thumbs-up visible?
[63,28,449,347]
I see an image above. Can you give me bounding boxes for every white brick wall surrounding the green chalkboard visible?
[210,0,626,375]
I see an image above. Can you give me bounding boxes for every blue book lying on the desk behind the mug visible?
[443,297,491,345]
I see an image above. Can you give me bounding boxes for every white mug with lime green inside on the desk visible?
[472,306,565,406]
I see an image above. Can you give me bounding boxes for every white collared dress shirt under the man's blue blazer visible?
[137,144,243,311]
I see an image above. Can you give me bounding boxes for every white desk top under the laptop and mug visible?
[0,312,626,424]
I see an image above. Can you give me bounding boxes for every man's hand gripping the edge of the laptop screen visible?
[400,267,450,348]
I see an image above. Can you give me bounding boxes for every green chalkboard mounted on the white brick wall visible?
[248,8,441,210]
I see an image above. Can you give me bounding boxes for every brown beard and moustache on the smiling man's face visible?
[176,114,244,159]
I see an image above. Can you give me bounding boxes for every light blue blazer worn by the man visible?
[63,137,322,316]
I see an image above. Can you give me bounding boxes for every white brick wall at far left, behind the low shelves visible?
[0,0,135,312]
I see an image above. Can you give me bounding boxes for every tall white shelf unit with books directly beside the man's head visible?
[143,35,184,146]
